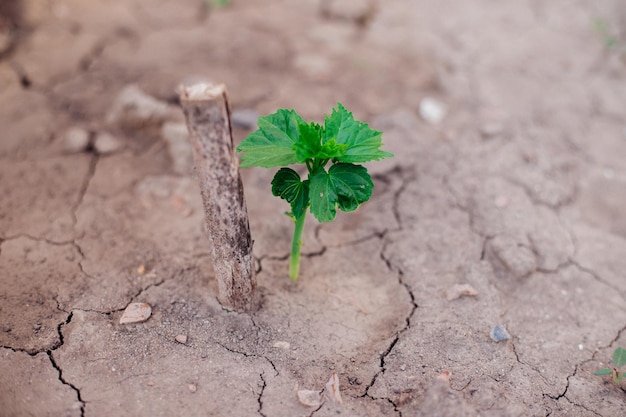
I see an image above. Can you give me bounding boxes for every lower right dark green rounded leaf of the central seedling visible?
[328,163,374,211]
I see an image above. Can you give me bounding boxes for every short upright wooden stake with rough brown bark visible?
[180,84,256,310]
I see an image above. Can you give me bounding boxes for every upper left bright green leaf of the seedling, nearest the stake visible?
[237,109,306,168]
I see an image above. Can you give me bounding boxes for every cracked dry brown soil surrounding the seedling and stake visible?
[0,0,626,417]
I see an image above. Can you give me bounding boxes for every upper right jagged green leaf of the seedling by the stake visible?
[322,103,393,162]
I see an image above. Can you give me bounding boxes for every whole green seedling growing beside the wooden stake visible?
[237,103,393,281]
